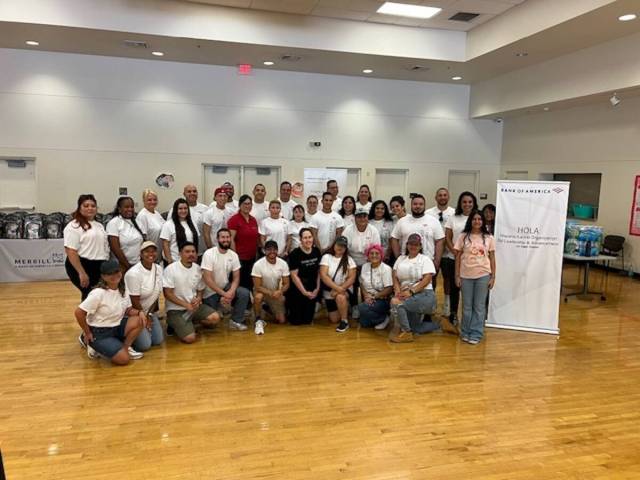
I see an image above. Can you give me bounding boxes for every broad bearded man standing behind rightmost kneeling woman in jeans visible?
[391,194,444,320]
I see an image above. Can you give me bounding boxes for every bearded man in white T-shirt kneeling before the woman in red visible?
[201,228,249,331]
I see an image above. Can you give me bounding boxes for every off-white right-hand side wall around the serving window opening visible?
[502,98,640,272]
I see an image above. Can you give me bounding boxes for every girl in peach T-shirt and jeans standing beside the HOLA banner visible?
[455,210,496,345]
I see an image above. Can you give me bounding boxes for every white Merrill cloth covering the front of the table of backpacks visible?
[0,239,67,283]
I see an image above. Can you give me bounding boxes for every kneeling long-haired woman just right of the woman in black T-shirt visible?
[320,236,356,333]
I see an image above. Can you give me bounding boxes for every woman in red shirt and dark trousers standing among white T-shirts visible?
[227,195,260,290]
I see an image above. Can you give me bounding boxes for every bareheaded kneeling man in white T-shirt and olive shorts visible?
[162,242,220,343]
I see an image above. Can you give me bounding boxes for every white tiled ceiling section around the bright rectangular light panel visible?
[184,0,524,31]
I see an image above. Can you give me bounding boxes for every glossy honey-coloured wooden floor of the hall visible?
[0,271,640,480]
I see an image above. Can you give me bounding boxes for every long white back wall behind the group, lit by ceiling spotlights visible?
[0,50,502,211]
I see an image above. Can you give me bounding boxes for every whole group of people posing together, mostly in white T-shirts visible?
[64,180,496,365]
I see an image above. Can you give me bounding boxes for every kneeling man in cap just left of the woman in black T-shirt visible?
[251,240,289,335]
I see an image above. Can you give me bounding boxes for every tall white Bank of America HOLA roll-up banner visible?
[487,180,569,334]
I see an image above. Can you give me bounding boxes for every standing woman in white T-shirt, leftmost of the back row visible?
[64,193,109,298]
